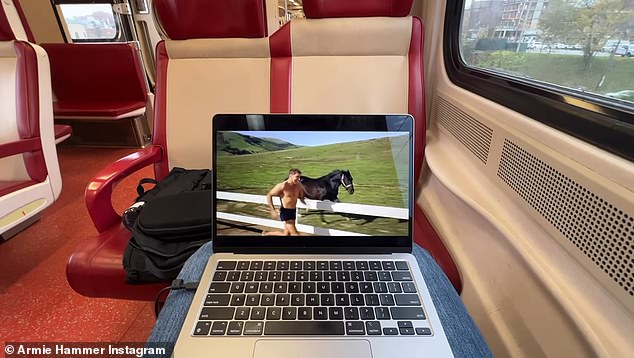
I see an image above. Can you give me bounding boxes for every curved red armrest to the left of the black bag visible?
[85,146,162,233]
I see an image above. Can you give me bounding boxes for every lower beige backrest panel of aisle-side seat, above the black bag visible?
[167,58,270,169]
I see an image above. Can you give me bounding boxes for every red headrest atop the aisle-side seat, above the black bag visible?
[154,0,267,40]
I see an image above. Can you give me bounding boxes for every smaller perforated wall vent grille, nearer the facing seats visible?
[435,97,493,164]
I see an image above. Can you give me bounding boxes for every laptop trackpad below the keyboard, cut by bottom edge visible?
[253,339,372,358]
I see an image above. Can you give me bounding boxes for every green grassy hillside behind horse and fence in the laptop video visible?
[217,137,408,235]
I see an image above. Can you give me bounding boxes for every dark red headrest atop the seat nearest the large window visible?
[303,0,414,19]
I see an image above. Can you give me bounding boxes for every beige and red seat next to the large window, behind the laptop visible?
[286,0,461,292]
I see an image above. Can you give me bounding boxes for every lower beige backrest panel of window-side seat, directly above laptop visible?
[291,56,408,113]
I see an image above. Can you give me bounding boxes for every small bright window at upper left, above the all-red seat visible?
[59,3,120,42]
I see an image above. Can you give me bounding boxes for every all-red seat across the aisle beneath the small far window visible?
[42,43,149,145]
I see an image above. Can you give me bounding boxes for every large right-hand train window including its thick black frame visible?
[443,0,634,160]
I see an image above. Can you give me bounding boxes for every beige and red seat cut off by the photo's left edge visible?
[0,1,62,239]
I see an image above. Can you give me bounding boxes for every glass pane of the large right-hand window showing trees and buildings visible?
[460,0,634,103]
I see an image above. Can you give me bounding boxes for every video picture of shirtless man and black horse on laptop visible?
[215,131,411,236]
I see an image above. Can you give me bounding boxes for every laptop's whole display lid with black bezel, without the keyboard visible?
[213,115,413,251]
